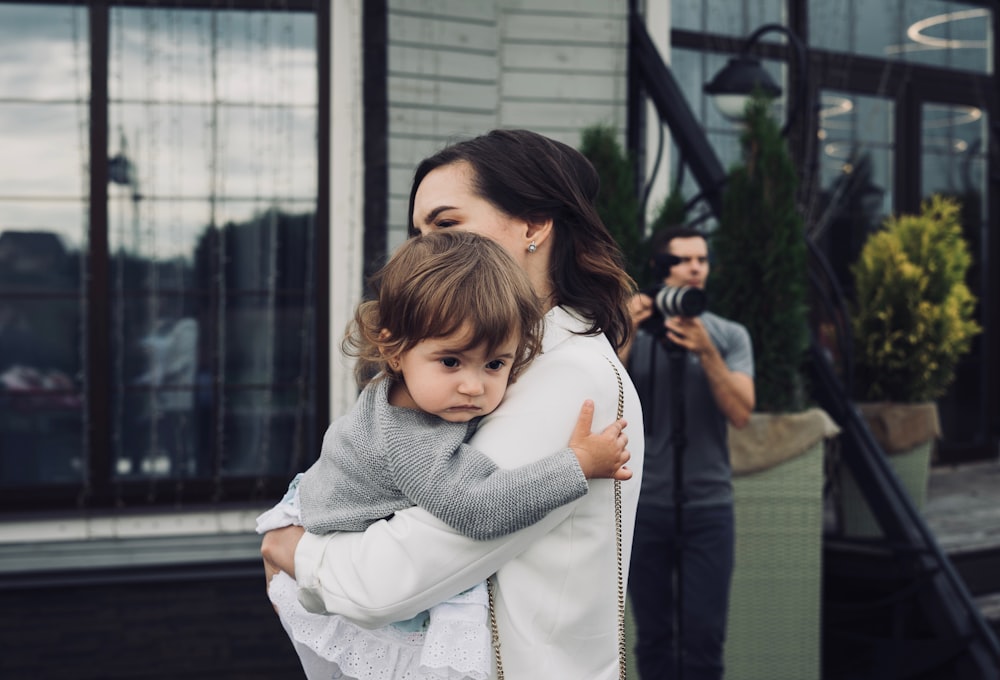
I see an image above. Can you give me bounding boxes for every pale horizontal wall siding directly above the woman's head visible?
[388,0,628,250]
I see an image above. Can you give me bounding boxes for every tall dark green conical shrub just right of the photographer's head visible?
[708,97,809,413]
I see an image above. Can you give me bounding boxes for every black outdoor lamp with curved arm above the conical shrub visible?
[704,24,806,134]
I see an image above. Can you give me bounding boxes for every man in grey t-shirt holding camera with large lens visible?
[621,227,755,680]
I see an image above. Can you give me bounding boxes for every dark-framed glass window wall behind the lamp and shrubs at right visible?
[670,0,1000,462]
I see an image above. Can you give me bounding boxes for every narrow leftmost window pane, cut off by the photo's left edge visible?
[0,3,89,487]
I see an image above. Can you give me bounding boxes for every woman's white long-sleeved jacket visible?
[295,307,644,680]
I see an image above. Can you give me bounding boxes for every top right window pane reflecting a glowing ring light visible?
[809,0,992,73]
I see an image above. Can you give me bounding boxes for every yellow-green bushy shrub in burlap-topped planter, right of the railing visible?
[840,195,981,535]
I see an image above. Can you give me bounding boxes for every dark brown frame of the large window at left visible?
[0,0,331,516]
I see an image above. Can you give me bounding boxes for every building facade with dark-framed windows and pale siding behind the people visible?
[0,0,1000,677]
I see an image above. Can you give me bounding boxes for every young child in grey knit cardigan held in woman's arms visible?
[258,231,631,679]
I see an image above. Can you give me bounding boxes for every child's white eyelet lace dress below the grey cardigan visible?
[257,477,492,680]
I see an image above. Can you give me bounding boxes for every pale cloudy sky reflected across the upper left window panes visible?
[0,4,317,257]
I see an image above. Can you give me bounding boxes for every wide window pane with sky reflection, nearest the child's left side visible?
[109,8,317,478]
